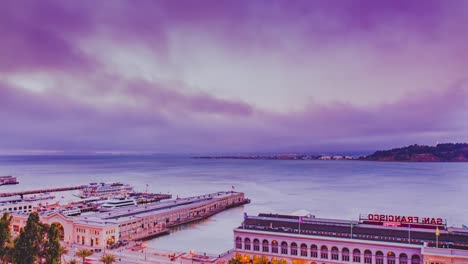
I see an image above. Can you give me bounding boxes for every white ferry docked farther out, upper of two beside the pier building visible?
[79,182,133,198]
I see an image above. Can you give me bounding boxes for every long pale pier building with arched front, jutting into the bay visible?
[11,191,248,247]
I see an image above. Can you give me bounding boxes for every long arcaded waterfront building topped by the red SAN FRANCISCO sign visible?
[234,214,468,264]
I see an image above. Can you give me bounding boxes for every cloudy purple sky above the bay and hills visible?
[0,0,468,153]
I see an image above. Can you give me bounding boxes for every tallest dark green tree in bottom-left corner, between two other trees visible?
[13,212,44,264]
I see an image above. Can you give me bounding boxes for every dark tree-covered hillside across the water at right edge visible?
[361,143,468,162]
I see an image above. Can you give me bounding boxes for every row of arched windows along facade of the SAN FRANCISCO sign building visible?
[236,237,421,264]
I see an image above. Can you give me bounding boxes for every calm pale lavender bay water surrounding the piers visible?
[0,156,468,254]
